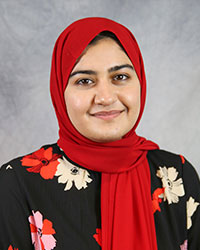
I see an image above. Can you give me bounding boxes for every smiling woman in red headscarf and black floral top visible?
[0,18,200,250]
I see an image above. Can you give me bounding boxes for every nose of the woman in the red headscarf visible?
[94,81,117,106]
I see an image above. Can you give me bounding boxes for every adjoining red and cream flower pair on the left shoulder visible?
[21,147,92,191]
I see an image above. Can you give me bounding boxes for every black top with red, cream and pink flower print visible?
[0,144,200,250]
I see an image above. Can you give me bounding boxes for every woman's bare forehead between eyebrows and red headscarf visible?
[72,38,132,72]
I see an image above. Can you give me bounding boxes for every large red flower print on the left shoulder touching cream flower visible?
[21,147,60,179]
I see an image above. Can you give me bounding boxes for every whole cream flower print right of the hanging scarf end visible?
[156,167,185,204]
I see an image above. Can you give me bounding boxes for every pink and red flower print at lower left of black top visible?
[28,211,56,250]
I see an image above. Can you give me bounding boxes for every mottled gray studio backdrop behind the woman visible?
[0,0,200,173]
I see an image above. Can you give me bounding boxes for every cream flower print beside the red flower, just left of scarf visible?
[55,157,92,191]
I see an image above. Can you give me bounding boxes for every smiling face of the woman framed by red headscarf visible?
[64,38,140,142]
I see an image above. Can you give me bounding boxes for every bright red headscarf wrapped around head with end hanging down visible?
[50,17,158,250]
